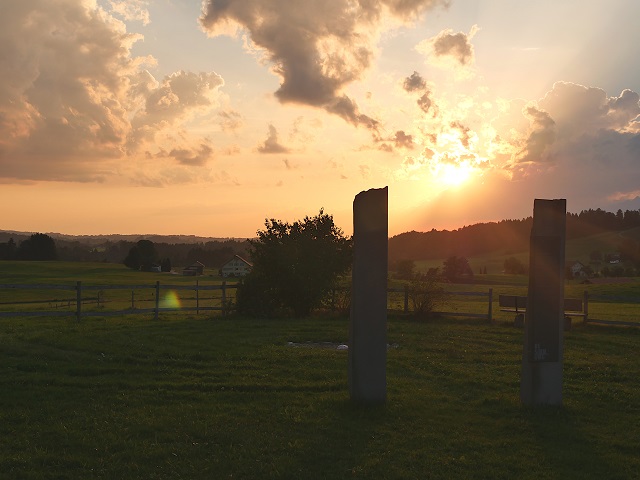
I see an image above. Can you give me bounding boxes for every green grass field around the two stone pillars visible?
[0,262,640,479]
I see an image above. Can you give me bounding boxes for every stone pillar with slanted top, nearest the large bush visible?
[349,187,389,403]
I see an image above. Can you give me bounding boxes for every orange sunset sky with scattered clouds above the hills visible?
[0,0,640,238]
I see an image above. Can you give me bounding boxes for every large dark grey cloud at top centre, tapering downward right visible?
[200,0,448,129]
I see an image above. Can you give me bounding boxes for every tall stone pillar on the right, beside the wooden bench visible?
[520,199,567,405]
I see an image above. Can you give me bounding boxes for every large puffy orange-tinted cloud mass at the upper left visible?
[0,0,223,181]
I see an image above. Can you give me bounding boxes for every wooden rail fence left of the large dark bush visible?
[0,281,238,321]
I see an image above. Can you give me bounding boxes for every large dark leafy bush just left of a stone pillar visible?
[237,209,351,317]
